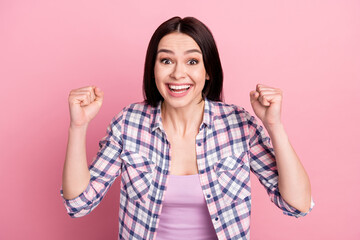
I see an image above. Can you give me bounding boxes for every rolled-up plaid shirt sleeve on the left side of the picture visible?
[60,114,122,218]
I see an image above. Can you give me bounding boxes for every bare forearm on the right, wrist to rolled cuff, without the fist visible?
[265,124,311,212]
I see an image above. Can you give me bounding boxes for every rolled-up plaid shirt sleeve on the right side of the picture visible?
[248,116,315,218]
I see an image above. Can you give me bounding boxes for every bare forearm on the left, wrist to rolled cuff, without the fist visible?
[62,124,90,199]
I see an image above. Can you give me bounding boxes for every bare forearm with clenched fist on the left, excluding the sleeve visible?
[62,87,104,199]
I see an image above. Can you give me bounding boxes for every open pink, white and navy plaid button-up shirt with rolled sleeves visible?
[61,99,314,239]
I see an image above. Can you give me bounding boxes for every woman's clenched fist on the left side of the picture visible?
[69,86,104,127]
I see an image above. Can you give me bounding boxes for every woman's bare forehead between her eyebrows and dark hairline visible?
[158,32,201,51]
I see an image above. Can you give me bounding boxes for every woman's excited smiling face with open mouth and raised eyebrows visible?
[154,32,208,108]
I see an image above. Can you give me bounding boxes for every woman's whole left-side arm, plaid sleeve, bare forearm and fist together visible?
[60,87,122,217]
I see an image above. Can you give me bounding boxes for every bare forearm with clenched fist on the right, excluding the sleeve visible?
[250,85,311,212]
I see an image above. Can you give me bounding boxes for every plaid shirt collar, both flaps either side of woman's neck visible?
[151,98,214,132]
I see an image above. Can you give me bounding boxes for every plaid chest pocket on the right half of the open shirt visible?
[214,152,251,203]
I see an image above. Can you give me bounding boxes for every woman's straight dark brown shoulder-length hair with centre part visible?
[143,17,223,107]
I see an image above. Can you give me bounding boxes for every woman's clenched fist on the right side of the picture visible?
[250,84,282,127]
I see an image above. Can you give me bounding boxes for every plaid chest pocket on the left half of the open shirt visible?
[120,150,155,202]
